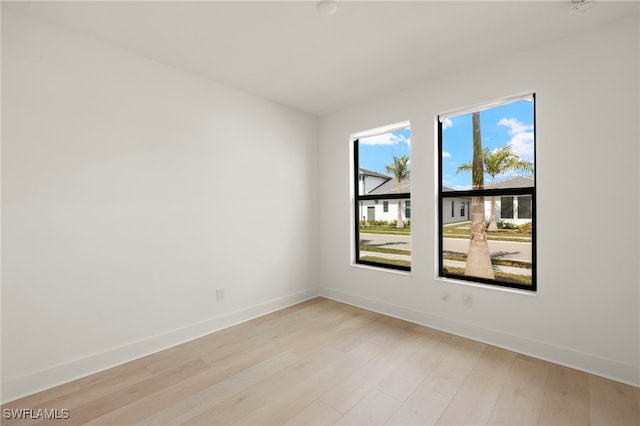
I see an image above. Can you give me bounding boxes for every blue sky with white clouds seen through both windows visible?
[358,100,534,189]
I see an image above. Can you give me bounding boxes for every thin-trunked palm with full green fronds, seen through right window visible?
[456,145,533,231]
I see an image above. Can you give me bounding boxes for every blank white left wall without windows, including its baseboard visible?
[2,11,317,401]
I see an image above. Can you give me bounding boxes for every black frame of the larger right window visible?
[436,92,538,293]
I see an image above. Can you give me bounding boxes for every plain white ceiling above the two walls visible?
[2,0,640,116]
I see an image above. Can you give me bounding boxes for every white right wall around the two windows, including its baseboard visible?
[319,16,640,385]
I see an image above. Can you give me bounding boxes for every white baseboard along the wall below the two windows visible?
[320,287,640,386]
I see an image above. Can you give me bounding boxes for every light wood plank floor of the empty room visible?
[2,298,640,426]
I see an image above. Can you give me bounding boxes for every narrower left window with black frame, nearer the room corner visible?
[353,123,411,271]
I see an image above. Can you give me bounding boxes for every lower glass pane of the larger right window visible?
[442,195,533,286]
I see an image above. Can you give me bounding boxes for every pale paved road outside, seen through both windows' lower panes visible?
[360,232,532,262]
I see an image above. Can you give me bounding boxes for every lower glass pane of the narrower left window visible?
[358,200,411,267]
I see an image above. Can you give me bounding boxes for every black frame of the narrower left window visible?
[353,137,411,272]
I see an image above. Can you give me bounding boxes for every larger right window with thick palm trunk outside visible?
[438,94,537,291]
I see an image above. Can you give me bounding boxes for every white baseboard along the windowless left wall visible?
[2,288,318,404]
